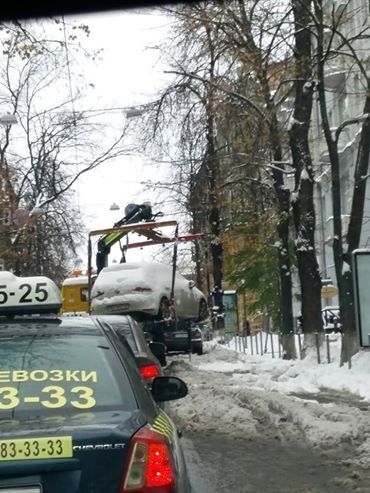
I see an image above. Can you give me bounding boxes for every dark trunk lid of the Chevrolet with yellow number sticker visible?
[0,411,145,493]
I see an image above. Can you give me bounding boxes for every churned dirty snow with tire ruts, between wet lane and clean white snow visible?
[166,356,370,470]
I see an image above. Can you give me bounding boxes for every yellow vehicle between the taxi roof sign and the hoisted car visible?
[61,271,96,315]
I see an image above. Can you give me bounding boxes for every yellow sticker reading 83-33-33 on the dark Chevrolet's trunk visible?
[0,436,73,461]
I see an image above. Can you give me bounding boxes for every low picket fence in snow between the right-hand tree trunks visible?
[220,331,352,368]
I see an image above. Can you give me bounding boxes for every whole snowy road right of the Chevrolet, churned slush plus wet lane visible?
[167,346,370,493]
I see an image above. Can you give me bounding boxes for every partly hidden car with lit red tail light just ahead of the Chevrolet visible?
[96,315,166,383]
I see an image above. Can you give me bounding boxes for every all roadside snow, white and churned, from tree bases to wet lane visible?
[167,336,370,466]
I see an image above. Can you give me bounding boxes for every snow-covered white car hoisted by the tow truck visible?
[91,262,208,320]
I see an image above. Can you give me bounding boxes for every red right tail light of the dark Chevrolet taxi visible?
[120,428,175,493]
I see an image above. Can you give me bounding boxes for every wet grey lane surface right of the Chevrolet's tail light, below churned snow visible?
[183,432,348,493]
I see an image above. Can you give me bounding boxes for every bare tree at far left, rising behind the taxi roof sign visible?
[0,21,132,279]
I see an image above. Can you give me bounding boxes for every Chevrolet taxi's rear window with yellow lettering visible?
[0,331,136,419]
